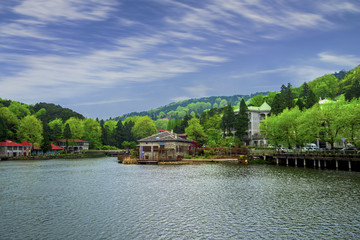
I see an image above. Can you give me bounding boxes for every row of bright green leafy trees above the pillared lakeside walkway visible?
[260,98,360,148]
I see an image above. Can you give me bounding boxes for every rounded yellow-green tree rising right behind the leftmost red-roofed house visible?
[17,115,43,143]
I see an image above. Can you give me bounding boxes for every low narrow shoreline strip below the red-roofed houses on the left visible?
[1,153,106,161]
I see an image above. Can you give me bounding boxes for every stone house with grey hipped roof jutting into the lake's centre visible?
[138,131,195,161]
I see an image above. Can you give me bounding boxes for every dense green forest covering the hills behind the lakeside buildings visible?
[0,66,360,151]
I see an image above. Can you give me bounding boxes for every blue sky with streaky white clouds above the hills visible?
[0,0,360,119]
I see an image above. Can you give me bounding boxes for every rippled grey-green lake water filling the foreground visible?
[0,158,360,239]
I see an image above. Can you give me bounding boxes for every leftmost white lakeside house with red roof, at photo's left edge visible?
[0,140,32,158]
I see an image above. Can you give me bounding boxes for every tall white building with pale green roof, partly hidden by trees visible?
[246,102,271,146]
